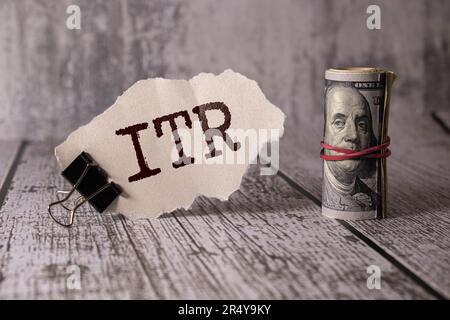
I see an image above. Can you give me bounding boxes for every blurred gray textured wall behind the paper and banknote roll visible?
[0,0,450,140]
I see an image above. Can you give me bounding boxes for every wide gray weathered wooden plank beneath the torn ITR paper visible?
[0,144,431,299]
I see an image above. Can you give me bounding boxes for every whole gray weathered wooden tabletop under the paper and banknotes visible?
[0,111,450,299]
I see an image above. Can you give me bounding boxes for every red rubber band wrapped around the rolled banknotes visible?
[320,137,391,161]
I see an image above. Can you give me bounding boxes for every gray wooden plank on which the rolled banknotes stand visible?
[280,110,450,298]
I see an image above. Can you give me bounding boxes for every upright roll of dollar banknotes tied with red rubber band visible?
[321,68,395,220]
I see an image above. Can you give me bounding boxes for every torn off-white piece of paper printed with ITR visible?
[55,70,285,218]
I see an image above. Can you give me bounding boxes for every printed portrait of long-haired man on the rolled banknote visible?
[322,84,379,211]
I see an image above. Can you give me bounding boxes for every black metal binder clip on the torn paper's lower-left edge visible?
[48,152,122,227]
